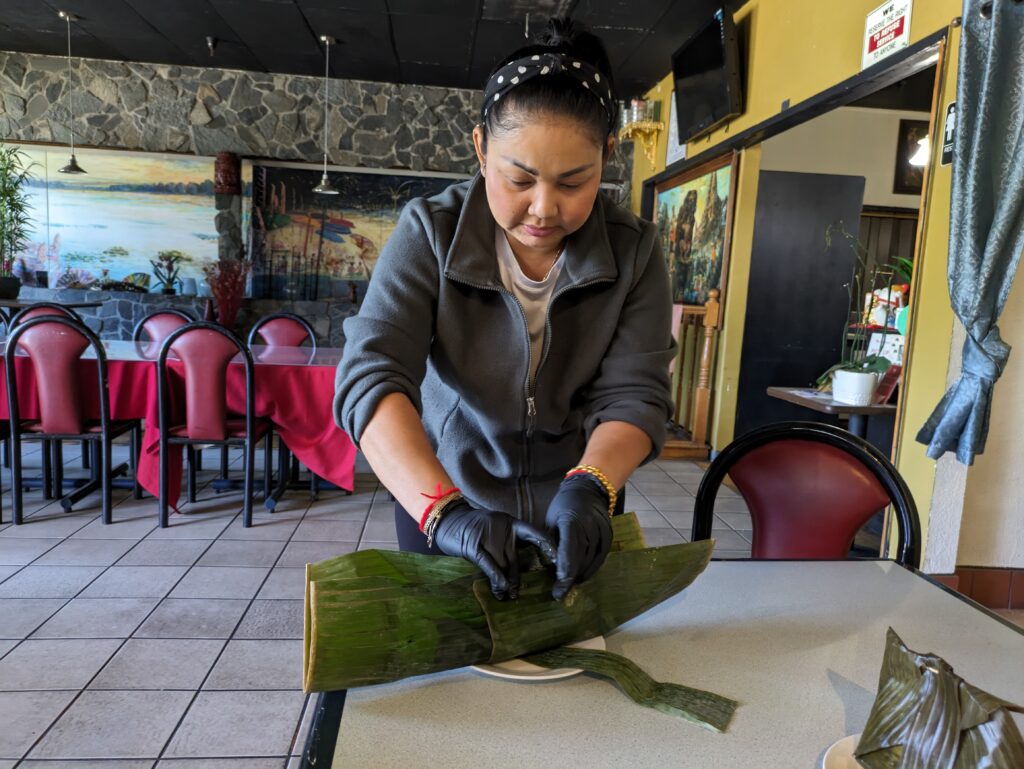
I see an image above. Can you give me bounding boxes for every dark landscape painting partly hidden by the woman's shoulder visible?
[249,164,466,299]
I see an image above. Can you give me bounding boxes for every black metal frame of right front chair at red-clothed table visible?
[157,321,270,528]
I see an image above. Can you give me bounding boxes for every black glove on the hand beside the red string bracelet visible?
[434,500,555,601]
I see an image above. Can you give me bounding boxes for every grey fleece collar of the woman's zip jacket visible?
[444,174,618,290]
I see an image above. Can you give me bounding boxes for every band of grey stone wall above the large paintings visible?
[0,51,632,185]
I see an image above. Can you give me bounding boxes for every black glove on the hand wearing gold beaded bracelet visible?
[546,474,611,601]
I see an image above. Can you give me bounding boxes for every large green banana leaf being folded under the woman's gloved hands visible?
[302,513,736,731]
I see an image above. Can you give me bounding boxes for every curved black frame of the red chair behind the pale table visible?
[692,422,921,568]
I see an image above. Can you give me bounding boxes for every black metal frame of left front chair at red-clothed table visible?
[4,315,142,524]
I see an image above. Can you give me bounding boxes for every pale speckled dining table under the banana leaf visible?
[302,560,1024,769]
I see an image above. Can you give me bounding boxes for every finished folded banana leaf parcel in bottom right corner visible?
[854,628,1024,769]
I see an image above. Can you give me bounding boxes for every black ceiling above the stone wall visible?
[0,0,742,97]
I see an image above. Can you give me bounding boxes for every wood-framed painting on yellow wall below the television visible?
[654,153,738,305]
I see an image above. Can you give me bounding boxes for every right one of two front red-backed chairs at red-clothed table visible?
[157,321,270,528]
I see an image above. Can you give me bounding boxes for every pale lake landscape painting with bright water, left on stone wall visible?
[15,145,217,288]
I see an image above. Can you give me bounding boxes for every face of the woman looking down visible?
[473,115,610,256]
